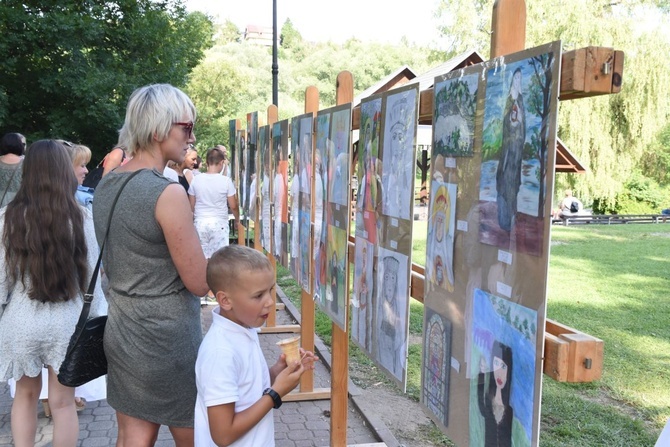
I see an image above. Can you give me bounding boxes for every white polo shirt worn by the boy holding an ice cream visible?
[195,308,275,447]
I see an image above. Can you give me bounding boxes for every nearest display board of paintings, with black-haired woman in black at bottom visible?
[422,42,561,446]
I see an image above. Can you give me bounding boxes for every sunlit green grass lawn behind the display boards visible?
[277,222,670,447]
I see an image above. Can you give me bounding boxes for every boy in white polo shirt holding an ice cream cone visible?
[195,245,316,447]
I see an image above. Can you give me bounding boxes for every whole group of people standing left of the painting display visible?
[0,84,316,447]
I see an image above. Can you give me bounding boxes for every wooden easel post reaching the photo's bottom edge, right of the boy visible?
[330,71,354,447]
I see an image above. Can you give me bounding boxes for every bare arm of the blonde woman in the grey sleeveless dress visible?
[156,183,209,296]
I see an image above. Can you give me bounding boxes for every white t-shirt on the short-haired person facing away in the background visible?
[188,173,237,219]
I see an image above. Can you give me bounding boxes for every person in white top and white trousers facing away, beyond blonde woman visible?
[188,148,240,259]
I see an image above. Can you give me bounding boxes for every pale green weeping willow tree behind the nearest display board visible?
[437,0,670,202]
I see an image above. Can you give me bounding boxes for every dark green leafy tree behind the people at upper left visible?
[0,0,212,159]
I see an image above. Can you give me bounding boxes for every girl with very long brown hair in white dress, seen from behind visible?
[0,140,104,447]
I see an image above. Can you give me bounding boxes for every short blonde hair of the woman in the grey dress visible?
[119,84,196,157]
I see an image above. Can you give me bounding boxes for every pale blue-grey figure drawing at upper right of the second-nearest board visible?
[382,84,419,220]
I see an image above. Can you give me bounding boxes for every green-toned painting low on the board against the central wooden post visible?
[317,225,349,332]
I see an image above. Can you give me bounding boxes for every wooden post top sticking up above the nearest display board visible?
[491,0,526,59]
